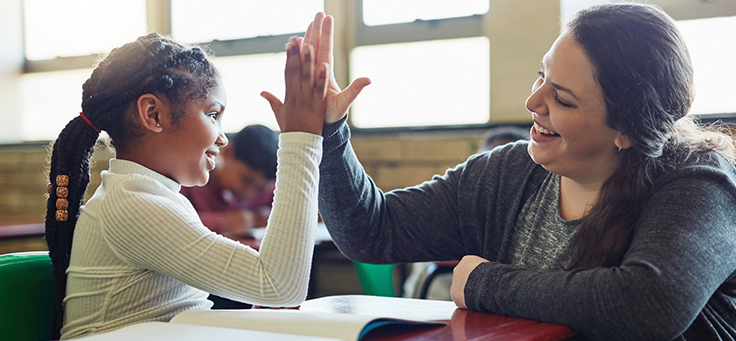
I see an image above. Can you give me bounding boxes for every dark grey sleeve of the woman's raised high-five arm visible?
[319,121,474,263]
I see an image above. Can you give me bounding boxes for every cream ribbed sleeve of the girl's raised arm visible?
[103,133,322,306]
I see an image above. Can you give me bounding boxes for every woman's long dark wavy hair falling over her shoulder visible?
[566,4,734,268]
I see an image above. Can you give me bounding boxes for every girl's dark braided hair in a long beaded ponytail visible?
[46,33,219,338]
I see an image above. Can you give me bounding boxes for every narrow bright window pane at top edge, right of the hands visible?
[363,0,488,26]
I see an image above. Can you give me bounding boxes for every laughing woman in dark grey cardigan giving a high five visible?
[300,4,736,340]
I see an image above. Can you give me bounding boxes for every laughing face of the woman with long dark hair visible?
[526,32,622,182]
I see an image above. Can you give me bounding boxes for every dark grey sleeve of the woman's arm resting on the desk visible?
[465,158,736,340]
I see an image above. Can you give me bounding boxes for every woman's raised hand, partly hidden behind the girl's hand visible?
[301,12,371,124]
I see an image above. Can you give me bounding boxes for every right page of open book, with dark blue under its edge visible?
[170,309,445,341]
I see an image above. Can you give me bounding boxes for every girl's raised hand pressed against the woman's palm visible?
[261,37,330,135]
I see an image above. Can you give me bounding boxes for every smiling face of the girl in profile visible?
[162,82,228,186]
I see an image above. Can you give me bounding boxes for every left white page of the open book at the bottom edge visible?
[79,322,338,341]
